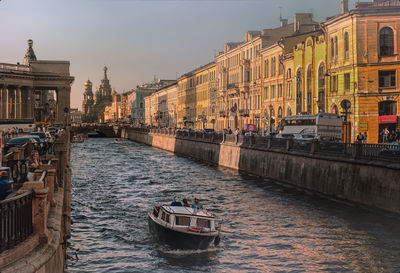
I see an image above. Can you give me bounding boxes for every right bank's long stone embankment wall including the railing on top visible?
[121,128,400,213]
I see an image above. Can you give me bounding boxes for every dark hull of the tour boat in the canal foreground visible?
[148,214,219,250]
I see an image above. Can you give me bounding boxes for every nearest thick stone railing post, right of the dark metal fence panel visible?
[32,188,49,243]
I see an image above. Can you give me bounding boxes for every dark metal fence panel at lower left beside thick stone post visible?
[0,191,33,253]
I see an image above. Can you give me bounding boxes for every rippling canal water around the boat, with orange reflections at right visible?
[66,139,400,273]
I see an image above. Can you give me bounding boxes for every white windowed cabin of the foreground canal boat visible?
[153,206,216,232]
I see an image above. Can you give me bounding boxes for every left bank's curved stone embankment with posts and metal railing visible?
[0,130,71,273]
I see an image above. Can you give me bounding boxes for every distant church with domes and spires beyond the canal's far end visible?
[82,66,112,122]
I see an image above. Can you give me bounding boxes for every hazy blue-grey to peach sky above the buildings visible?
[0,0,356,108]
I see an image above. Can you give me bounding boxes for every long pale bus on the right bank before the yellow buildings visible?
[281,113,343,139]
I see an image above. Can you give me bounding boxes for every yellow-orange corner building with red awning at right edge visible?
[323,0,400,143]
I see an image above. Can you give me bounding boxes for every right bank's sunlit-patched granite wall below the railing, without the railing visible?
[122,128,400,213]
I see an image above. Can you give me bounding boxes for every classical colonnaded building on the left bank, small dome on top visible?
[0,40,74,123]
